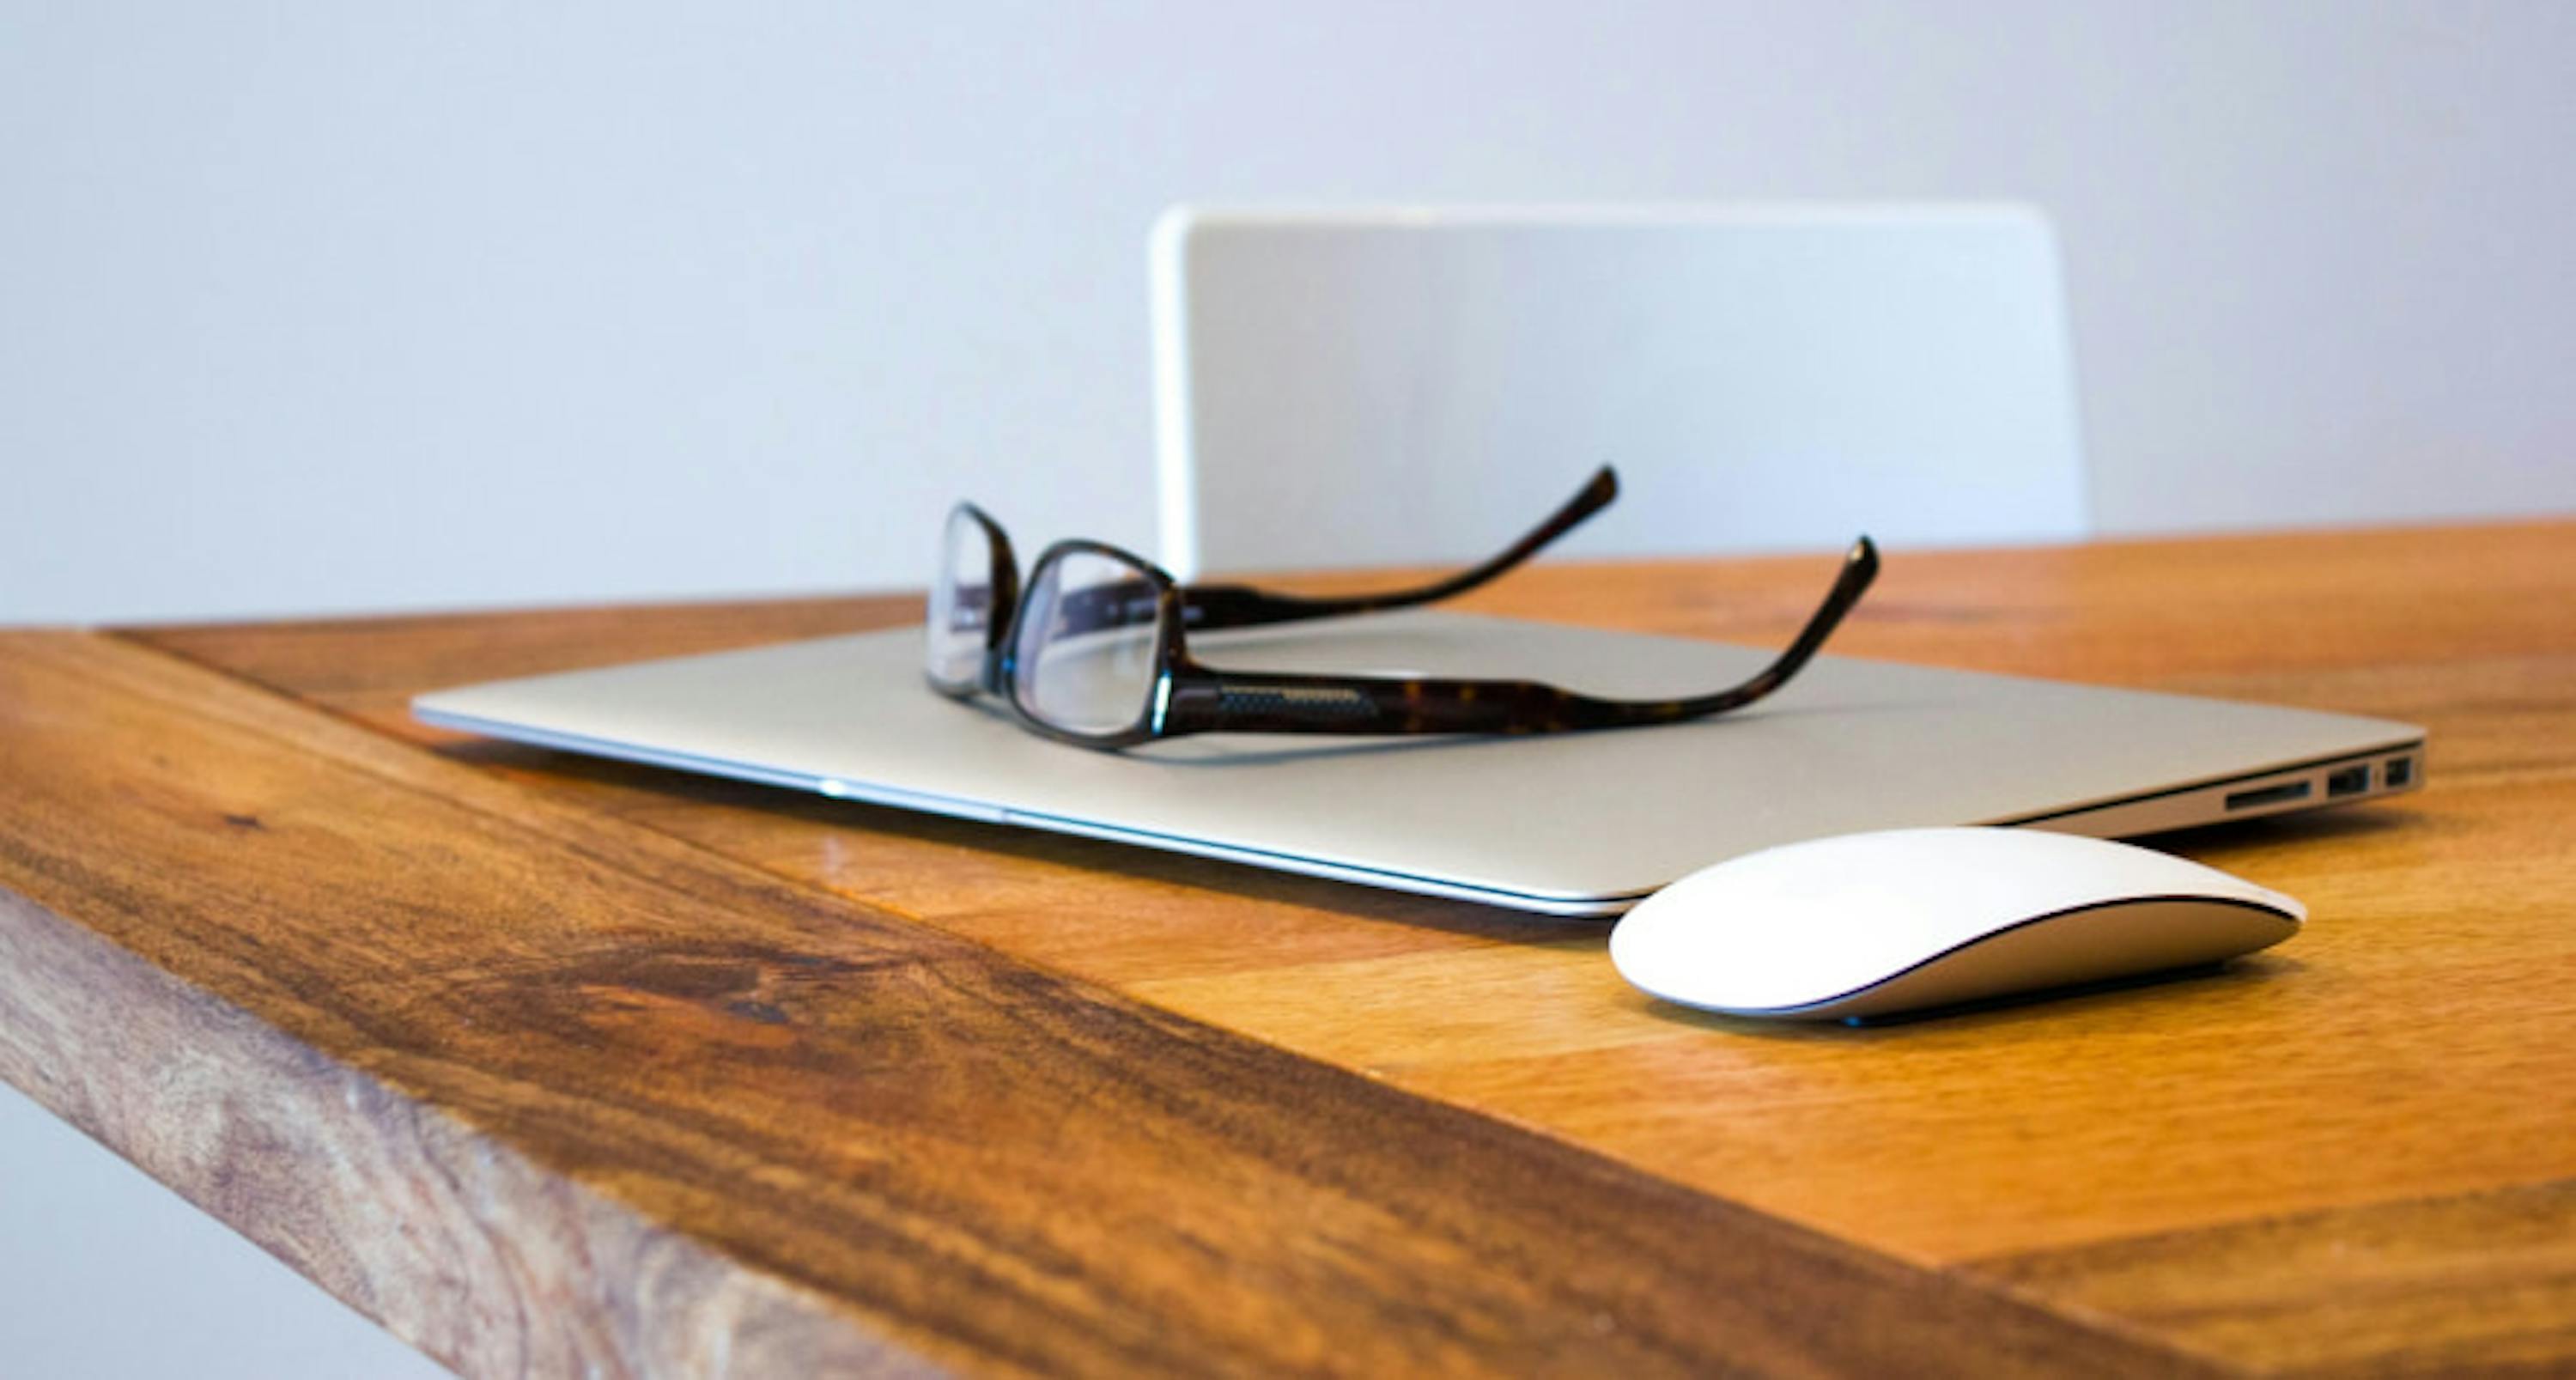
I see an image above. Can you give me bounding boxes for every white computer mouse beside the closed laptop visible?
[1610,829,2308,1019]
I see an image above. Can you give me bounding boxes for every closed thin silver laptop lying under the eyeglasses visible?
[412,611,2424,916]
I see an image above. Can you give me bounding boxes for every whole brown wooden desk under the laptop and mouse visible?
[0,523,2576,1375]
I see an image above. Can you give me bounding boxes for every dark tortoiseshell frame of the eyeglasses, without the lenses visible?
[927,466,1878,749]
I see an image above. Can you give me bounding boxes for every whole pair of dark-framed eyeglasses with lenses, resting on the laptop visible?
[925,466,1878,749]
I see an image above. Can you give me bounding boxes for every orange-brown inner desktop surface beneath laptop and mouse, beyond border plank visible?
[70,523,2576,1370]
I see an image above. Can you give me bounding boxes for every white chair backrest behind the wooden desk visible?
[1151,206,2089,577]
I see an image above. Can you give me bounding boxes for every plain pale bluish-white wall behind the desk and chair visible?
[0,0,2576,621]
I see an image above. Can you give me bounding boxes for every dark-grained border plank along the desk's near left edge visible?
[0,634,2192,1375]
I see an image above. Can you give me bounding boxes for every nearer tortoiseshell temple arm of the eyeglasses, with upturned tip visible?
[1159,538,1878,736]
